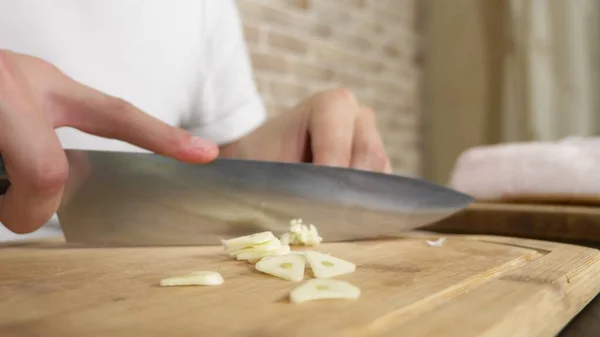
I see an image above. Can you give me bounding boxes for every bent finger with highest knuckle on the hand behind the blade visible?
[309,89,358,167]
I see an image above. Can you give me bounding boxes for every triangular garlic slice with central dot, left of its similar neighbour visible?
[255,254,306,282]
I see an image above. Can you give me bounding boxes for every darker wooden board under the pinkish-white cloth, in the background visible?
[426,202,600,247]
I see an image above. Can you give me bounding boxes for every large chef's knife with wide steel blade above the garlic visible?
[0,150,473,246]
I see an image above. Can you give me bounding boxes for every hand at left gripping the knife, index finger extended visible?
[0,49,219,233]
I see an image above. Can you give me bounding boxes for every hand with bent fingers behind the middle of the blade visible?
[221,89,392,173]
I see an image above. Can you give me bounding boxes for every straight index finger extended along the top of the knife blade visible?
[55,81,219,163]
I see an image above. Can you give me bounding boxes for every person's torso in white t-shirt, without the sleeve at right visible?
[0,0,211,150]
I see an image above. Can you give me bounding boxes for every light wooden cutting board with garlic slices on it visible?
[0,234,600,337]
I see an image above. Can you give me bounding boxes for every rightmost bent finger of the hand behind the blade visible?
[350,107,389,172]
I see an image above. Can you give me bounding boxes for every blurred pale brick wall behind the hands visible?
[237,0,422,176]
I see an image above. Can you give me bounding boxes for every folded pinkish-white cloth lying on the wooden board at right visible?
[450,137,600,201]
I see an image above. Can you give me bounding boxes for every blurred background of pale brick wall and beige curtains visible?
[237,0,600,184]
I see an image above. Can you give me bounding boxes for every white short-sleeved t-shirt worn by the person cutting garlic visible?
[0,0,266,241]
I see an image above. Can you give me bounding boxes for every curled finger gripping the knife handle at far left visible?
[0,55,68,233]
